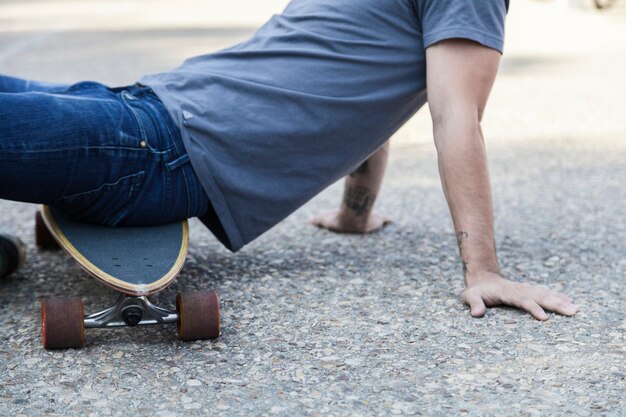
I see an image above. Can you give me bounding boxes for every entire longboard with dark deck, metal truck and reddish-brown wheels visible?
[35,206,220,349]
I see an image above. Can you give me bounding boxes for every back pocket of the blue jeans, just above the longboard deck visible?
[54,171,145,226]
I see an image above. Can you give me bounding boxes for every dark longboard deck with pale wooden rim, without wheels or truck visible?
[41,206,189,296]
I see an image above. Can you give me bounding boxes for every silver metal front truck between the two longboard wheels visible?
[85,294,179,329]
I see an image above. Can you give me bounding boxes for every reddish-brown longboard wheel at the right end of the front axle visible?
[176,290,220,342]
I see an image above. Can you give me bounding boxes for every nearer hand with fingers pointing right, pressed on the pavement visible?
[461,272,578,321]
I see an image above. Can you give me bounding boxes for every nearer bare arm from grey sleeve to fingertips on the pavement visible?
[426,40,578,320]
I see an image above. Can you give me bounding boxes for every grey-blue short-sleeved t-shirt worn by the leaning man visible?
[140,0,508,251]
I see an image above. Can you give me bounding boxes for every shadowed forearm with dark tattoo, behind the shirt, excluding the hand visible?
[340,142,389,224]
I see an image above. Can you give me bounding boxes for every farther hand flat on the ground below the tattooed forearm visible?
[309,209,391,234]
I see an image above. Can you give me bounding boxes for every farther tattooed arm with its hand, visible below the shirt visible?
[311,142,389,233]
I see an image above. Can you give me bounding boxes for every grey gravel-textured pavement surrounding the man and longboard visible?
[0,0,626,417]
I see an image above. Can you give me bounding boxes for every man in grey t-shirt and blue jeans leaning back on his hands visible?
[0,0,577,320]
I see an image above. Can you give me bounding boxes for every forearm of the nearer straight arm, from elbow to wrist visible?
[435,122,499,283]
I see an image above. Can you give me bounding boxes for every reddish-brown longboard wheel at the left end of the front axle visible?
[41,298,85,349]
